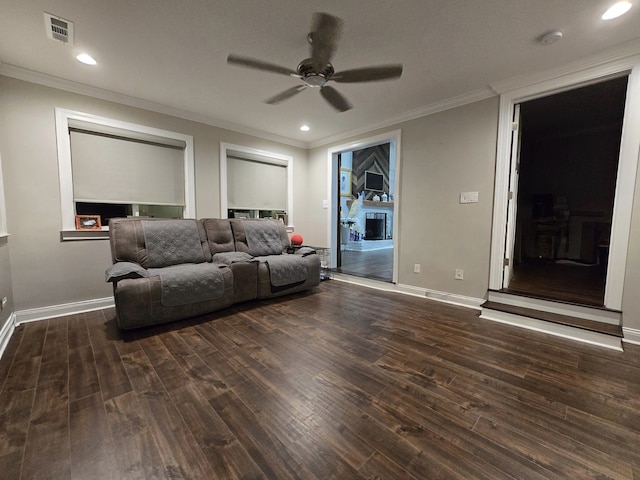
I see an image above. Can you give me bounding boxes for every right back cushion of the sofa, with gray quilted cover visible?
[230,218,289,257]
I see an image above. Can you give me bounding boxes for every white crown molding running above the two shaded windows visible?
[0,62,308,149]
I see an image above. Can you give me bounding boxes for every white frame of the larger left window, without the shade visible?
[55,107,196,240]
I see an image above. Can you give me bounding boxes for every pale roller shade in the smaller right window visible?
[227,156,287,211]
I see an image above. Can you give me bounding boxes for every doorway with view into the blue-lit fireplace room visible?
[329,131,400,282]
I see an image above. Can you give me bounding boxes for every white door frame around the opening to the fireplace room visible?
[327,130,402,283]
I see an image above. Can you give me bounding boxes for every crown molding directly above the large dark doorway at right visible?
[490,40,640,94]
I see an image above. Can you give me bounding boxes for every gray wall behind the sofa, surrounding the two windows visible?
[0,77,308,318]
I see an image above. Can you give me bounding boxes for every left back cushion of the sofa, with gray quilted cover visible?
[109,218,211,268]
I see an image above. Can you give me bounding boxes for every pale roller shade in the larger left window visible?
[70,130,185,205]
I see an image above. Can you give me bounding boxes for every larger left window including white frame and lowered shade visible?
[56,109,195,239]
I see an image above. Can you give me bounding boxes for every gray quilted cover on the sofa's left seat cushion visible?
[149,263,226,307]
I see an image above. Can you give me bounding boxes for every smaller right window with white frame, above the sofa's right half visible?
[220,143,293,225]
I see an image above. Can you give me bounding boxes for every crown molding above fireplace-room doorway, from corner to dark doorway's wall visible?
[309,88,496,149]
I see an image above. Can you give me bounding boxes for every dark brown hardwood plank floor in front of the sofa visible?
[0,280,640,480]
